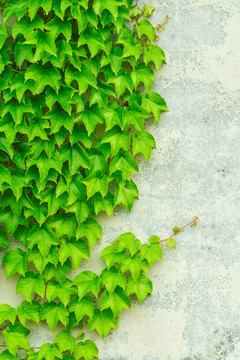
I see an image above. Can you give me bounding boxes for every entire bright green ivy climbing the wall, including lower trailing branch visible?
[0,0,197,360]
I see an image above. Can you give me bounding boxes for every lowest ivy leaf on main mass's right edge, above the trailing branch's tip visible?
[114,180,139,212]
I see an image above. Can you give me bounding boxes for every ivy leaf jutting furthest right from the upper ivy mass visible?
[142,91,168,124]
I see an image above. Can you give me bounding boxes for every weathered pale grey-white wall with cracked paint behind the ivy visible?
[0,0,240,360]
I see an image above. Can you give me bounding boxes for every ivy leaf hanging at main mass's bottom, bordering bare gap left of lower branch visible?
[59,238,90,270]
